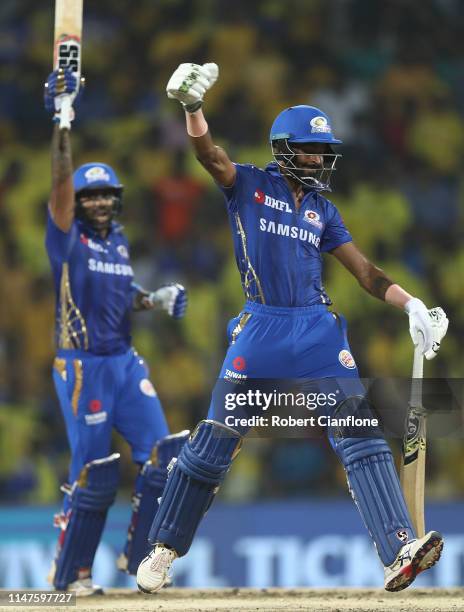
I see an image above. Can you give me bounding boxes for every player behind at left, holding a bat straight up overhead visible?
[45,70,188,596]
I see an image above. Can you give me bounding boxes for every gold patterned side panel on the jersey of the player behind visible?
[58,263,89,350]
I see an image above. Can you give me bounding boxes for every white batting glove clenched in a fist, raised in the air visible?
[166,63,219,113]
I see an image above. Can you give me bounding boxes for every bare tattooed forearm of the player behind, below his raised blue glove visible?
[50,124,74,231]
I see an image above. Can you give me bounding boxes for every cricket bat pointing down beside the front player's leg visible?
[400,346,426,538]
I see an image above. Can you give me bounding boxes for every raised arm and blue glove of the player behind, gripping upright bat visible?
[44,69,80,232]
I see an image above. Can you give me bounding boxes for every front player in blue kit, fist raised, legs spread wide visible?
[137,64,448,593]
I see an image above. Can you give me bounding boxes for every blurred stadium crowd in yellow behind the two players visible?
[0,0,464,586]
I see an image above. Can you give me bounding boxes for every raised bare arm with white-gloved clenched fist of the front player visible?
[166,63,236,187]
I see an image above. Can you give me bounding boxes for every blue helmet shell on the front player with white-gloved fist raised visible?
[269,104,342,145]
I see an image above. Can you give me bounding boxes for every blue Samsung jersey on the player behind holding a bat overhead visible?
[46,213,135,355]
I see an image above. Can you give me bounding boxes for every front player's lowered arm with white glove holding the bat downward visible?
[332,242,448,359]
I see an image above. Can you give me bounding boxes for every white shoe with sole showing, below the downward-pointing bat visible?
[384,531,443,591]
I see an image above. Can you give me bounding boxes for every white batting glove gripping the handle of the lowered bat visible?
[404,298,449,360]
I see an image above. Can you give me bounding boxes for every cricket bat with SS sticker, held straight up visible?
[53,0,83,129]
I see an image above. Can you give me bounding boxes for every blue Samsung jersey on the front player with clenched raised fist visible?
[221,163,352,306]
